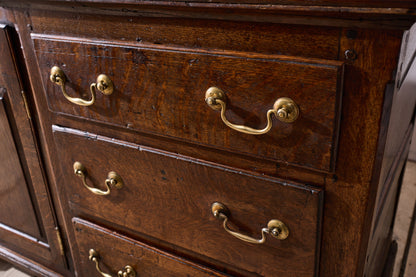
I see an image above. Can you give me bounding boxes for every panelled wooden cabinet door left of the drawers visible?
[0,24,65,273]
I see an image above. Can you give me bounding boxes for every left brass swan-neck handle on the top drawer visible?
[50,66,114,106]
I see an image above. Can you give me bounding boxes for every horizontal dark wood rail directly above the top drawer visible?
[31,10,340,60]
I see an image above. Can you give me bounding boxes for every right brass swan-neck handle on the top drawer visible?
[205,87,299,135]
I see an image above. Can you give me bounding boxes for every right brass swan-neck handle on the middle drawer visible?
[211,202,289,244]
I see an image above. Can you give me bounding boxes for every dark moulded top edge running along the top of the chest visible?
[5,0,416,30]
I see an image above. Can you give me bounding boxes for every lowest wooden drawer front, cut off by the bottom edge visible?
[72,218,226,277]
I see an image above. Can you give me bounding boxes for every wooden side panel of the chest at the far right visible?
[365,23,416,275]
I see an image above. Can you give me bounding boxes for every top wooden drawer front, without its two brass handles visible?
[33,35,343,171]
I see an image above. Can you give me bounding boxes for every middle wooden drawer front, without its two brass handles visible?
[54,126,322,277]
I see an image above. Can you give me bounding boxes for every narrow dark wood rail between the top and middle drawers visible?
[52,112,333,187]
